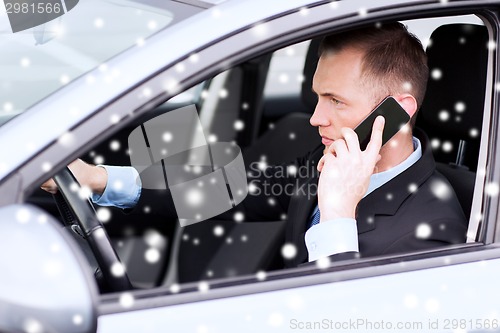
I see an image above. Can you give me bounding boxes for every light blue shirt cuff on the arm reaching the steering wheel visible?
[92,165,142,208]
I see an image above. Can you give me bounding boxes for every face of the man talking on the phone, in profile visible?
[310,48,376,147]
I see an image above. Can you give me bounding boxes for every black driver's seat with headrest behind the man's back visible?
[416,24,488,223]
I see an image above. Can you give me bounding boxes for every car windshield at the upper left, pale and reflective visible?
[0,0,202,125]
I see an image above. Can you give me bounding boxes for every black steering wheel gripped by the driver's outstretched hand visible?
[53,167,133,291]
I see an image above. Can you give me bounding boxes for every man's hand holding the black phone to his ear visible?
[318,116,385,222]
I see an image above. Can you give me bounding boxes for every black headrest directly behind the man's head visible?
[417,24,488,141]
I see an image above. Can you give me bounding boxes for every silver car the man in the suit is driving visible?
[0,0,500,333]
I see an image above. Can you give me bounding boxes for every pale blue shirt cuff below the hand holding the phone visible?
[305,218,359,261]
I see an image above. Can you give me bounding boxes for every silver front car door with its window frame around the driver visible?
[2,1,500,332]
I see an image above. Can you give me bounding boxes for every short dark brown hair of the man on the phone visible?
[319,22,429,123]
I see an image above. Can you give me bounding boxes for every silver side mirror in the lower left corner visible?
[0,205,98,333]
